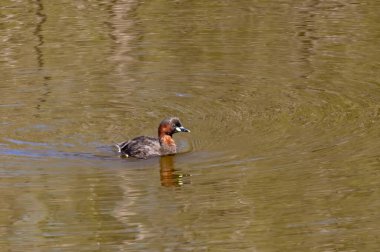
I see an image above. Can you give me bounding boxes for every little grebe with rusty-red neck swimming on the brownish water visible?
[116,117,190,159]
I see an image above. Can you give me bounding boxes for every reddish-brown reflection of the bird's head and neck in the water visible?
[160,155,191,187]
